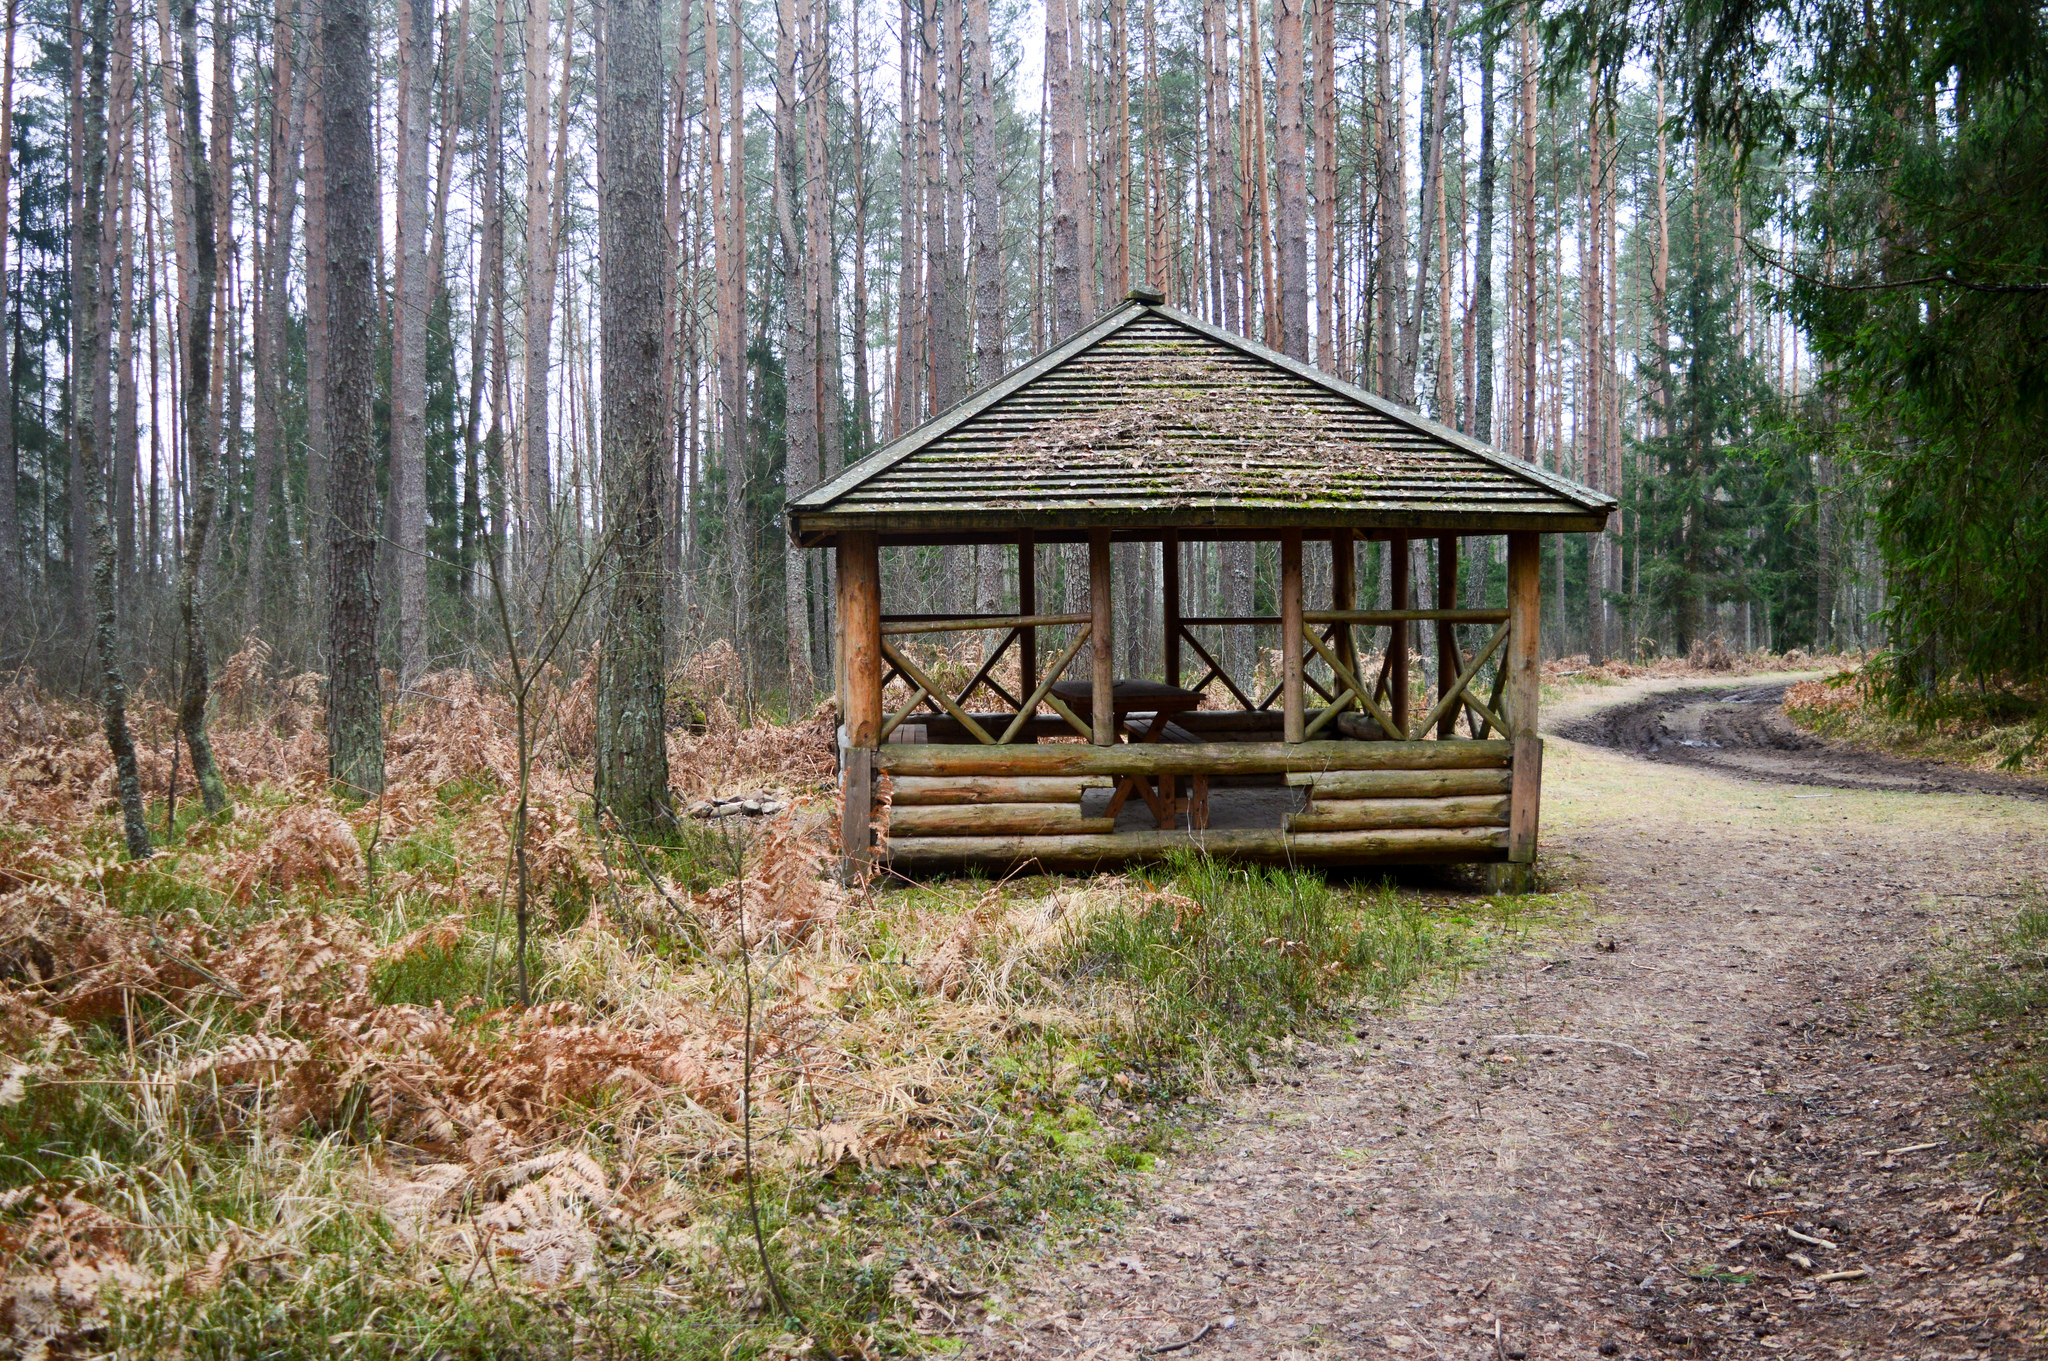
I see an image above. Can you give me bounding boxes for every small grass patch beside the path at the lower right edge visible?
[1919,894,2048,1199]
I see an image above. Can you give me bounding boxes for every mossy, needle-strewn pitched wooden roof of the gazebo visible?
[788,301,1614,542]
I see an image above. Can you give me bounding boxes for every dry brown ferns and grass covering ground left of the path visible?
[0,645,1515,1357]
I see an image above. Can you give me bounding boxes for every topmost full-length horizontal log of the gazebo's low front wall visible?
[877,741,1513,776]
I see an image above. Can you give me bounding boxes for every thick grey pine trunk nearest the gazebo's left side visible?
[596,0,675,835]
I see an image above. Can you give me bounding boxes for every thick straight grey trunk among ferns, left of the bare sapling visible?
[319,0,383,798]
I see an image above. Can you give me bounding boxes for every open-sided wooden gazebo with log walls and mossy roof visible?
[788,291,1614,876]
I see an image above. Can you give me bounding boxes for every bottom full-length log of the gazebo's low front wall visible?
[889,827,1507,870]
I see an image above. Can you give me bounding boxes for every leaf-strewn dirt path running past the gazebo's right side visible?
[967,679,2048,1361]
